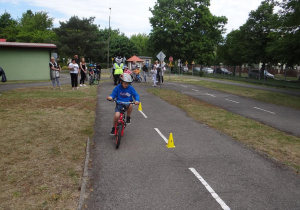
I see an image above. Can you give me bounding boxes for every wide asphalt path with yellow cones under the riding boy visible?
[86,82,300,209]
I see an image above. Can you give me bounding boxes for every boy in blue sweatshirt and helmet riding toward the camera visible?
[107,73,140,135]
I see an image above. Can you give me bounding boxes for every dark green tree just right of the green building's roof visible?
[54,16,106,61]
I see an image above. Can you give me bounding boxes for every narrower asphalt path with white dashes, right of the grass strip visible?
[162,82,300,137]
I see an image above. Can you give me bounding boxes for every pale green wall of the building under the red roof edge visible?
[0,47,50,81]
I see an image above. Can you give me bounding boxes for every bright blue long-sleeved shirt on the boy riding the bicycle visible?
[110,84,140,102]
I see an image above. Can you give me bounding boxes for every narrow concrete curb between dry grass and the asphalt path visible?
[77,138,90,210]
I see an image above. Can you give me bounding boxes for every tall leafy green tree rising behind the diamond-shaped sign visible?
[150,0,227,64]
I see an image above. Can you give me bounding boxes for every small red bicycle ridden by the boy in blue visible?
[111,100,135,149]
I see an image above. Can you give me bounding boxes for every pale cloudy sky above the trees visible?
[0,0,262,37]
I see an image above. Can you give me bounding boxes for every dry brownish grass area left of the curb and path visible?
[0,85,97,209]
